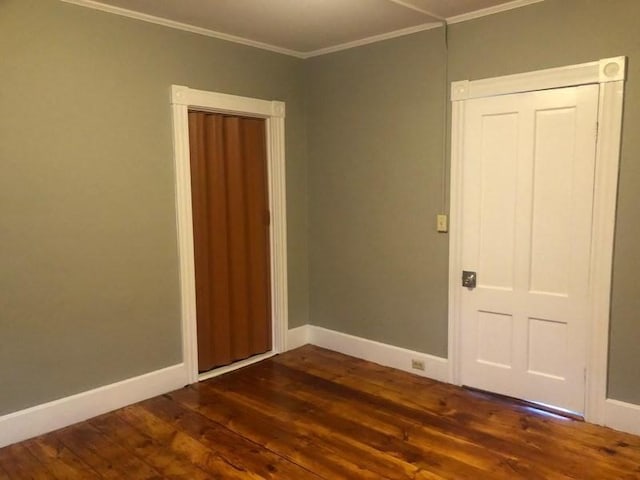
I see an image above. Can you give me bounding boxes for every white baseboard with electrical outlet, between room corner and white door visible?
[308,325,449,382]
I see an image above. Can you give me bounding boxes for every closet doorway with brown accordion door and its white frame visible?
[172,86,288,383]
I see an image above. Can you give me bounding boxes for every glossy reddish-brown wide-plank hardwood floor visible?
[0,346,640,480]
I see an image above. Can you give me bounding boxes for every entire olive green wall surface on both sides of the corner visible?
[0,0,640,415]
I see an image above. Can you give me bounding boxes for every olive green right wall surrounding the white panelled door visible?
[306,0,640,403]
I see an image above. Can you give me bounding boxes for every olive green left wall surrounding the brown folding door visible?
[0,0,308,415]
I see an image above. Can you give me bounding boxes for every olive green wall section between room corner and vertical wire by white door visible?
[307,29,449,356]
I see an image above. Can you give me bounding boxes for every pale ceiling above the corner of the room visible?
[63,0,542,57]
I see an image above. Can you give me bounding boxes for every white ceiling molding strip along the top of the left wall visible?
[60,0,306,58]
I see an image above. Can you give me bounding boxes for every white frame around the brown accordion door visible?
[171,85,288,383]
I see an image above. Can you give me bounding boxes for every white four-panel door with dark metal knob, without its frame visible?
[460,85,599,412]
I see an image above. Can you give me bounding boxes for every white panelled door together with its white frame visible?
[449,57,626,423]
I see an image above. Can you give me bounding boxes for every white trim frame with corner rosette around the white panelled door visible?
[449,57,626,424]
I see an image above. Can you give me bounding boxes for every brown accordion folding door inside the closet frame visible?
[189,112,271,372]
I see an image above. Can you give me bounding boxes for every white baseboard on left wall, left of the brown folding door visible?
[0,363,189,448]
